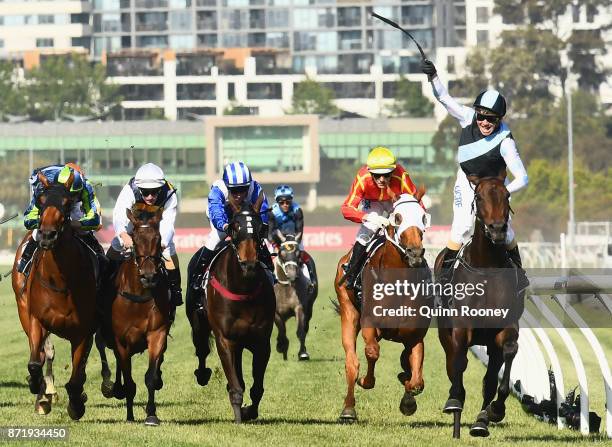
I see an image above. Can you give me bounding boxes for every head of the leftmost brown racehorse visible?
[36,172,74,250]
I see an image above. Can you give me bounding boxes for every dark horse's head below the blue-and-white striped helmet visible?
[227,193,264,276]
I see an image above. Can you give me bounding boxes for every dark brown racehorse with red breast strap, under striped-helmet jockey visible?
[189,195,276,424]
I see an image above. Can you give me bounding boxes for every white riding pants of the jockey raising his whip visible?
[450,168,514,244]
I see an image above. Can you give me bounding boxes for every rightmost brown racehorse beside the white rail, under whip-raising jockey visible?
[436,172,523,438]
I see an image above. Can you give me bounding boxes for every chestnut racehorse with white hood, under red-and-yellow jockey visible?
[334,188,428,422]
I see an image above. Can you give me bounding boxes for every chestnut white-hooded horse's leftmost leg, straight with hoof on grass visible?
[339,298,359,422]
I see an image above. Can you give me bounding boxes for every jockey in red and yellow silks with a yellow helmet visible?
[341,146,416,290]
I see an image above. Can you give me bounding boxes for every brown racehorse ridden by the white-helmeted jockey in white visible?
[111,209,170,426]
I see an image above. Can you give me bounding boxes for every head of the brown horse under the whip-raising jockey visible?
[468,169,510,245]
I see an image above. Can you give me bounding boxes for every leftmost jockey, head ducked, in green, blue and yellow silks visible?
[17,163,104,273]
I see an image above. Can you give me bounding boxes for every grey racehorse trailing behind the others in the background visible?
[274,234,317,360]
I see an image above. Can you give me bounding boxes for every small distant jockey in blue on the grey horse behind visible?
[268,185,317,289]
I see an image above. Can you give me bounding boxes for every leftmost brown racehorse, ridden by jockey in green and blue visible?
[12,174,96,420]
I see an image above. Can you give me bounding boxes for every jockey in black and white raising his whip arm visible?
[421,60,529,289]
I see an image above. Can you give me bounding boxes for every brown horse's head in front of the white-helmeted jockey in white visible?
[126,208,163,289]
